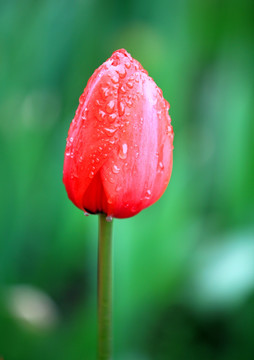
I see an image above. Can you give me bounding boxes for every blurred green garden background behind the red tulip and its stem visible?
[0,0,254,360]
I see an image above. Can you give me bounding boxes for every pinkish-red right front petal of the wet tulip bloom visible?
[101,72,173,218]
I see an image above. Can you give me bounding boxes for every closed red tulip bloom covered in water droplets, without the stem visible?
[63,49,174,218]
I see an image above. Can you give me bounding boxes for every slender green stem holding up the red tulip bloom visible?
[98,214,112,360]
